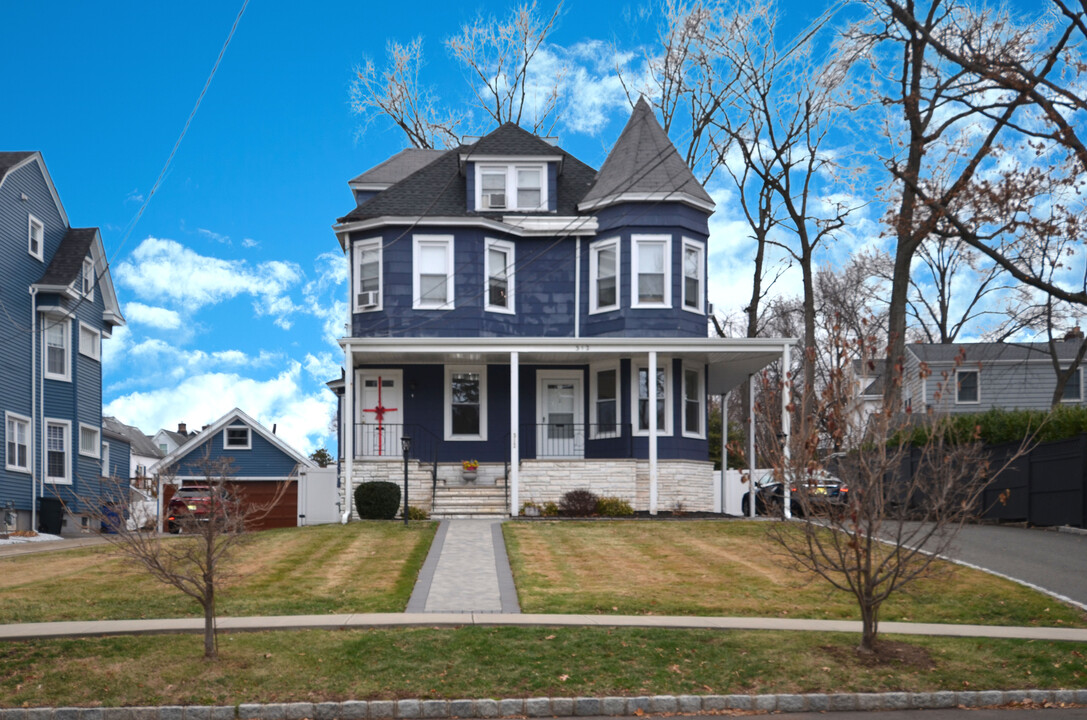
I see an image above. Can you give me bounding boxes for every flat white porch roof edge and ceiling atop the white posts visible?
[340,337,796,395]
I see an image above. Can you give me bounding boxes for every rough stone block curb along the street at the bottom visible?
[0,690,1087,720]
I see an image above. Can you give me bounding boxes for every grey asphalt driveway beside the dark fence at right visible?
[947,525,1087,608]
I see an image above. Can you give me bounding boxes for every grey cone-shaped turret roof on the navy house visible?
[578,97,714,212]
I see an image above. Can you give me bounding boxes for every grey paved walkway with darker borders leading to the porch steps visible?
[408,520,521,613]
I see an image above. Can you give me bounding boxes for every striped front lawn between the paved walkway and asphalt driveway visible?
[503,521,1087,628]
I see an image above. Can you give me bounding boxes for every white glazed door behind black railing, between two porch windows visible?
[536,370,585,458]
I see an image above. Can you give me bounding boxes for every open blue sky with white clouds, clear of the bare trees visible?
[0,0,847,452]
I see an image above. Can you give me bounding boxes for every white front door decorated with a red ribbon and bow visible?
[354,370,403,458]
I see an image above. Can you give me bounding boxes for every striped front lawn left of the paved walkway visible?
[0,522,437,623]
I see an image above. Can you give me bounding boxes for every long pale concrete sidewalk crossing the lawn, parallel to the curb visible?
[0,612,1087,643]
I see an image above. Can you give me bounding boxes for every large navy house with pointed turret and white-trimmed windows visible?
[332,100,787,513]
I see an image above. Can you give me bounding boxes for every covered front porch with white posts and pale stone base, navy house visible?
[341,337,792,514]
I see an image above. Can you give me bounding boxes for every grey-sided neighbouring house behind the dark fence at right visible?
[902,328,1085,413]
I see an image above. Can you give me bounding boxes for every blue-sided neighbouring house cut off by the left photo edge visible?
[0,152,127,532]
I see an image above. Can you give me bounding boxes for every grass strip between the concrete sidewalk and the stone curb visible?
[0,626,1087,707]
